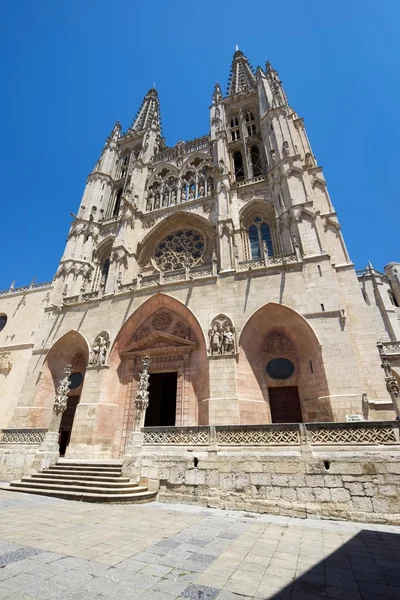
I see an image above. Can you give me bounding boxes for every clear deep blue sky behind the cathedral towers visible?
[0,0,400,289]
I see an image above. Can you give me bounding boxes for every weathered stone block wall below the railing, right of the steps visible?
[124,438,400,525]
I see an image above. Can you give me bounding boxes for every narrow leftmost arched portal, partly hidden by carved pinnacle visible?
[35,331,89,456]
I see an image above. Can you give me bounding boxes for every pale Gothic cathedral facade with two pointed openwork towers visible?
[0,51,400,459]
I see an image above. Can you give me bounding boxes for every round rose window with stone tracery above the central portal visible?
[154,229,205,271]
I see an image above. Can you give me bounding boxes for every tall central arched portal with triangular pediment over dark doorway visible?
[110,293,209,454]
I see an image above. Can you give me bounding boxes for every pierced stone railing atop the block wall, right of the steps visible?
[142,421,400,446]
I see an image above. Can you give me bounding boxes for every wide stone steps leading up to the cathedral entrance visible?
[2,459,156,503]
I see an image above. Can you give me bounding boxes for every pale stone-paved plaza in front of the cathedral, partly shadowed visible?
[0,491,400,600]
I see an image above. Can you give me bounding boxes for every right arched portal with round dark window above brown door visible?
[238,302,333,423]
